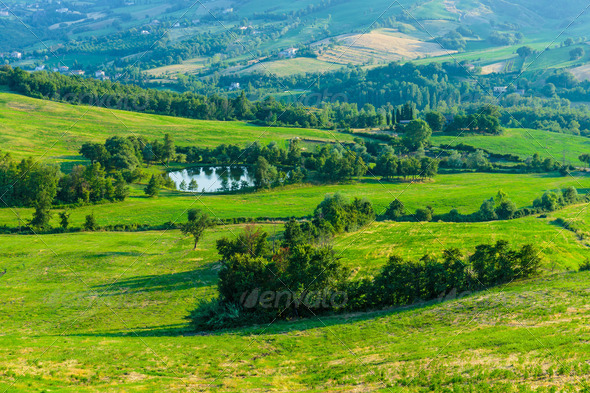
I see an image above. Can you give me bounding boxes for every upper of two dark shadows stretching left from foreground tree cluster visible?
[92,262,217,296]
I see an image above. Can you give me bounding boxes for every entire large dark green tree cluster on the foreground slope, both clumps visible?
[189,221,541,330]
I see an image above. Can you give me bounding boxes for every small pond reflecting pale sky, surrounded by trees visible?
[168,166,254,192]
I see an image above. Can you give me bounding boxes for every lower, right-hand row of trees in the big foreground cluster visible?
[368,241,541,308]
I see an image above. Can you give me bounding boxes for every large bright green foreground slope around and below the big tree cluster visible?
[0,224,590,392]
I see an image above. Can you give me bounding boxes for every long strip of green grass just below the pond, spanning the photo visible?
[0,173,590,226]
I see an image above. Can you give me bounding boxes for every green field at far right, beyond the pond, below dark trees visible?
[432,128,590,165]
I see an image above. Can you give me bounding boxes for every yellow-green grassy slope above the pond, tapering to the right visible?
[0,93,352,161]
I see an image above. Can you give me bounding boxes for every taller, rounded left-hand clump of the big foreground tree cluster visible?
[190,227,346,330]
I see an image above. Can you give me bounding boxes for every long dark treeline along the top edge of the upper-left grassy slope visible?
[0,66,506,132]
